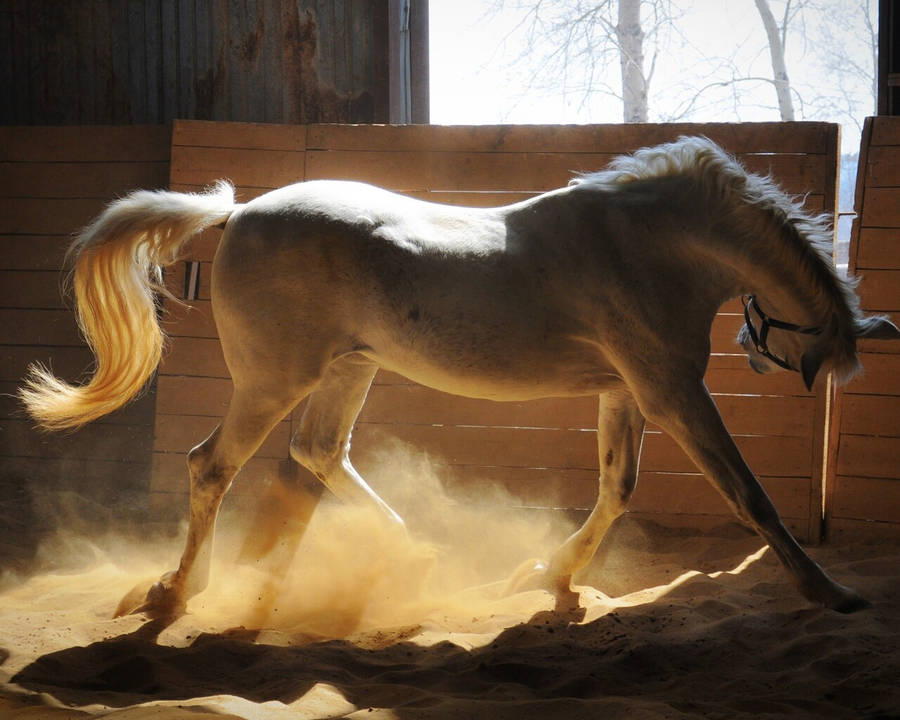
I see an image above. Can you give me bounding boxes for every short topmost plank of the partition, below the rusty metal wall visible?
[172,120,307,152]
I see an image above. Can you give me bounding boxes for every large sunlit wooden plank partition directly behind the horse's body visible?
[152,122,837,539]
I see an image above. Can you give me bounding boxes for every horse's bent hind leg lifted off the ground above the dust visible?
[291,355,403,524]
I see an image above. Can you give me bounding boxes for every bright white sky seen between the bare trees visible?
[429,0,876,152]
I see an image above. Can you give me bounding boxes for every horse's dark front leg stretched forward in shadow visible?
[640,377,869,612]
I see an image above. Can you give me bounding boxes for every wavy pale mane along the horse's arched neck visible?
[570,136,877,382]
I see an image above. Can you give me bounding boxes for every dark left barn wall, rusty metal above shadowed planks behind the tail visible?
[0,0,394,570]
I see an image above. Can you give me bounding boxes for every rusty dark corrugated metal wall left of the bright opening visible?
[0,0,388,125]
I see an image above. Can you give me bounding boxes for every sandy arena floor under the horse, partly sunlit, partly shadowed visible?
[0,458,900,720]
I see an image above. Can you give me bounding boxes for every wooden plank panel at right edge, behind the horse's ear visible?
[826,117,900,536]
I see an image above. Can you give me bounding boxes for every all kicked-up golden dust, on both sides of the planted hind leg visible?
[0,443,574,642]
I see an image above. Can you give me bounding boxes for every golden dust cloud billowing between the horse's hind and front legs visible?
[199,443,574,638]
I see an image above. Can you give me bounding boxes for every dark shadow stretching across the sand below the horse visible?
[12,578,898,720]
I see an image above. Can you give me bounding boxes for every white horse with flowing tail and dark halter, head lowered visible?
[21,138,900,615]
